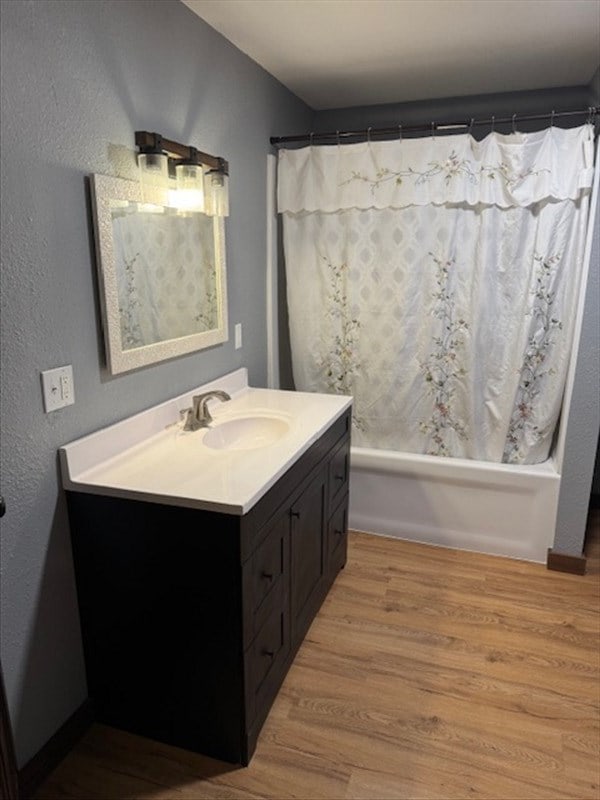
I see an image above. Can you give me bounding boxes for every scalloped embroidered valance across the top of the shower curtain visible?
[278,125,594,213]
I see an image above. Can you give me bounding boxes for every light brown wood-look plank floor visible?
[36,513,600,800]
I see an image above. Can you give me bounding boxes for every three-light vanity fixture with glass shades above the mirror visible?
[135,131,229,217]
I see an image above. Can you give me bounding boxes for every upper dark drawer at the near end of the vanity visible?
[243,514,289,648]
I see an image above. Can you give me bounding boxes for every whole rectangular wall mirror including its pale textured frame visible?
[92,175,228,374]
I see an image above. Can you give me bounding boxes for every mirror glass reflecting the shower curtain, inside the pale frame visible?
[111,201,218,350]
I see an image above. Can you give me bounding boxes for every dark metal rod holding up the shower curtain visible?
[269,106,599,145]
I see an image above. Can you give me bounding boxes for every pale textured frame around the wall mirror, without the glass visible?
[91,175,229,375]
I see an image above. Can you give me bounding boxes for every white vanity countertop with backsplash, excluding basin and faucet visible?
[59,369,352,515]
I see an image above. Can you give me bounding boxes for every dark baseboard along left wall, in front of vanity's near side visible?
[19,698,94,800]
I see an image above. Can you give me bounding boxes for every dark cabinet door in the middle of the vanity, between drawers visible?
[290,470,327,644]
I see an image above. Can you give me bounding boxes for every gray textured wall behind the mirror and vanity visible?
[0,0,312,765]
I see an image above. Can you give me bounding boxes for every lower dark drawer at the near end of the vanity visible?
[246,606,290,723]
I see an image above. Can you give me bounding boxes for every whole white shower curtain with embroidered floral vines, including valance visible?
[278,125,593,463]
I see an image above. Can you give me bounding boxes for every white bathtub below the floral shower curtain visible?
[349,448,560,562]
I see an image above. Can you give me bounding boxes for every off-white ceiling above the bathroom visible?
[183,0,600,109]
